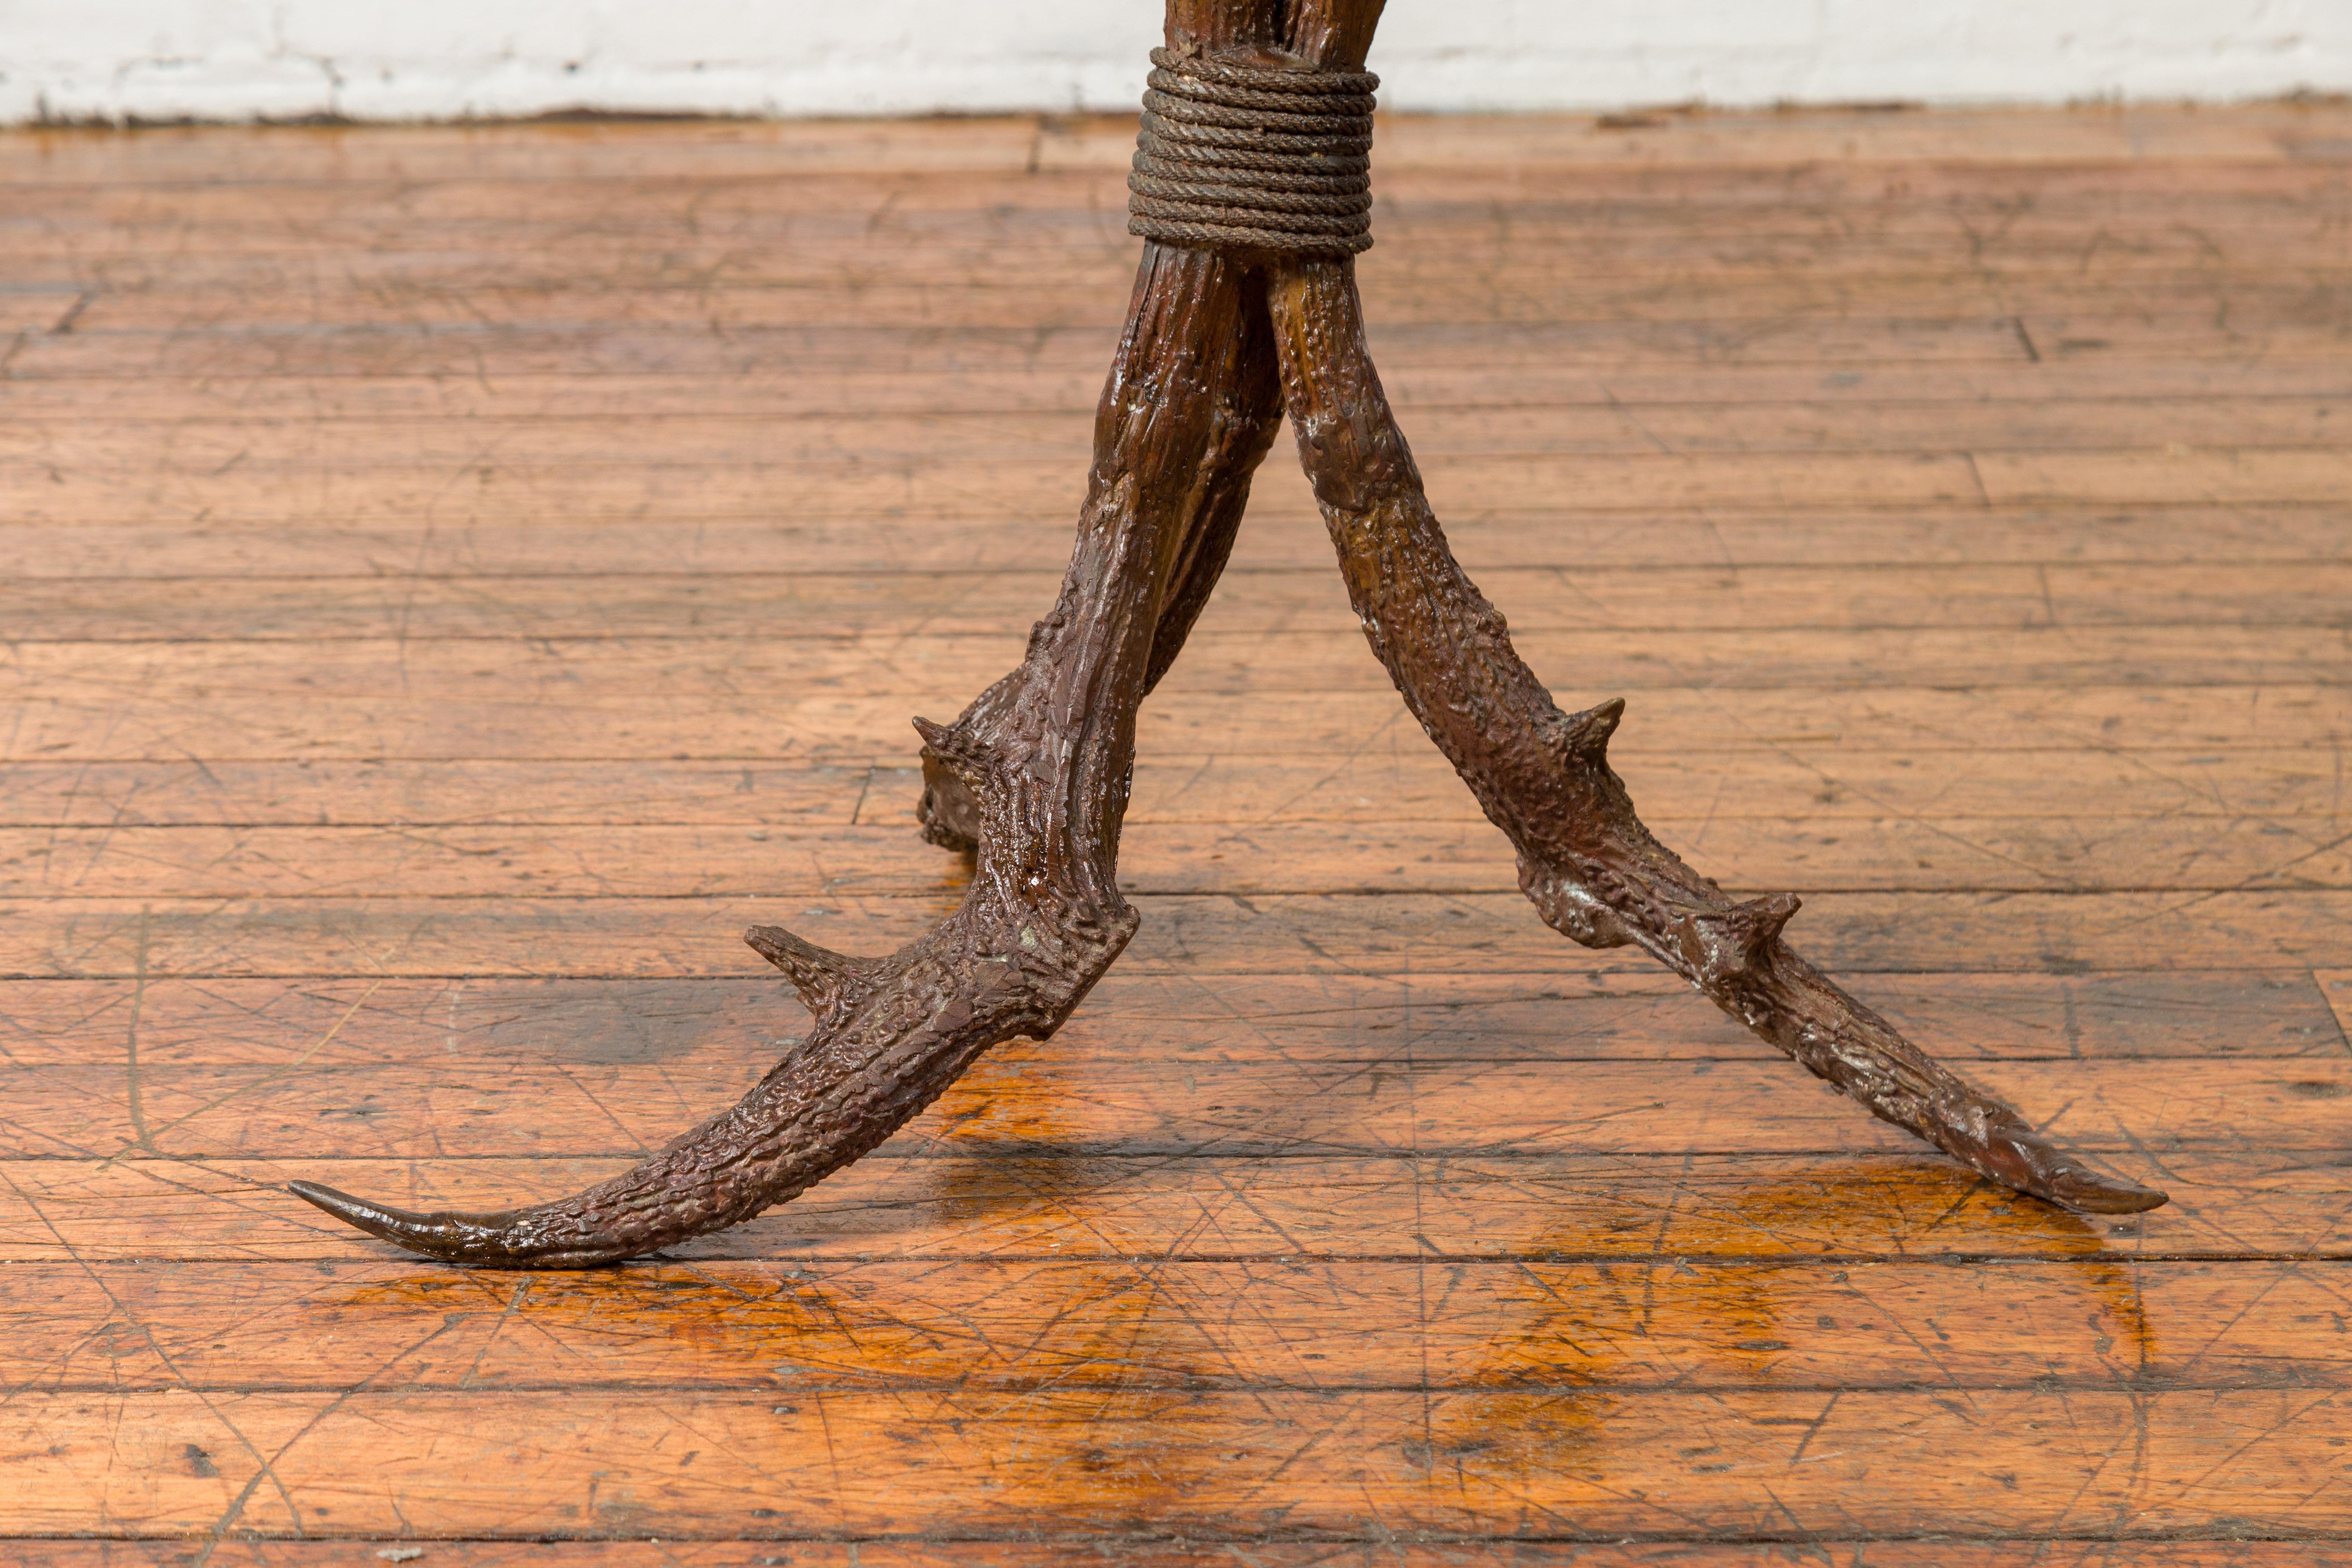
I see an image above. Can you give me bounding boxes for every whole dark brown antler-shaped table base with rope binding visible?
[292,0,2164,1269]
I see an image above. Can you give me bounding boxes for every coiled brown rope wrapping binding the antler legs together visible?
[1127,49,1381,256]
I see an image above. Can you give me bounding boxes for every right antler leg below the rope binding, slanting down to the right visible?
[1268,259,2164,1213]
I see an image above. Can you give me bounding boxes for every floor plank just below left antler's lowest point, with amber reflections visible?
[0,1258,2324,1396]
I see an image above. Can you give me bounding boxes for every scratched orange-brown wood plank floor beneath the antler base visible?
[0,104,2352,1568]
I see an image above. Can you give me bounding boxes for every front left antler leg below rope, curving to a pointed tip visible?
[289,245,1277,1269]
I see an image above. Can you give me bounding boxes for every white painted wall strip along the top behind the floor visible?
[0,0,2352,122]
